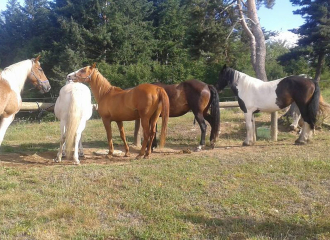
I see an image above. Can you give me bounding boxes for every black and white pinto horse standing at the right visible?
[216,66,320,146]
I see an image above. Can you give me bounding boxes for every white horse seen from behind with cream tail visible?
[54,81,93,165]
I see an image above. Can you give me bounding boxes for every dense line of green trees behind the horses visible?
[0,0,330,98]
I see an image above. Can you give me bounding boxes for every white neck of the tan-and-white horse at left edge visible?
[1,60,32,94]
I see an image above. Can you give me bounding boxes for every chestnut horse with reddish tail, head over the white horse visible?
[67,63,169,159]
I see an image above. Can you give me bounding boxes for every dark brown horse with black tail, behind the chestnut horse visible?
[136,79,220,151]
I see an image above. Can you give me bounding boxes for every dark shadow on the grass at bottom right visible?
[181,214,330,239]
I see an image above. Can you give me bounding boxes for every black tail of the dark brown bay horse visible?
[209,85,220,141]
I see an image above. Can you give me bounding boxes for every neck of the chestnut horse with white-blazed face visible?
[90,71,113,102]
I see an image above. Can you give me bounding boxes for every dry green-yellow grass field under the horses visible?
[0,110,330,239]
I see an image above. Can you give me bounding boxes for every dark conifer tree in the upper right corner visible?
[290,0,330,81]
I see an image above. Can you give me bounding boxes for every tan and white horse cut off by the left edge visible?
[0,56,51,146]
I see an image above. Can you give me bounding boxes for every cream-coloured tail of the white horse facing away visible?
[65,89,82,158]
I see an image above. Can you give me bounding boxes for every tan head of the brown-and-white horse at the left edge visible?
[28,56,51,93]
